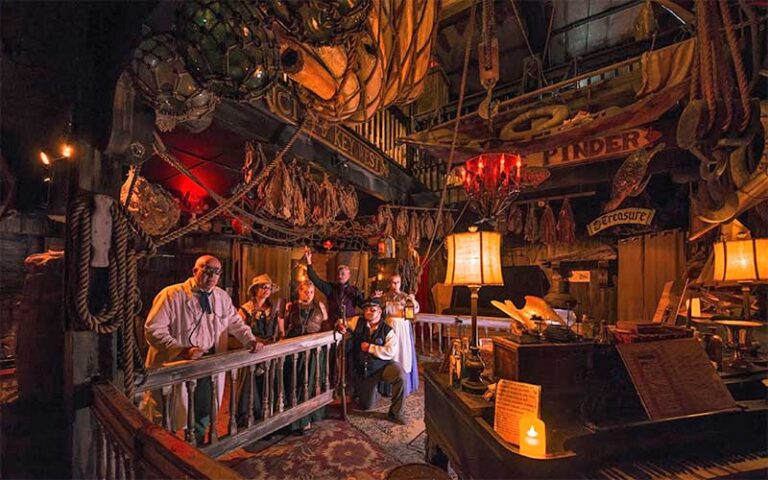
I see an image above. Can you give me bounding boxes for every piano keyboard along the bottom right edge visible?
[587,450,768,480]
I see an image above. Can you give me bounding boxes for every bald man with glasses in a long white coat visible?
[143,255,264,444]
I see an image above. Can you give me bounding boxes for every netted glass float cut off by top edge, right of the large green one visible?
[267,0,373,46]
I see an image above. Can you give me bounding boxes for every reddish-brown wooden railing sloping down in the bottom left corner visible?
[90,383,243,480]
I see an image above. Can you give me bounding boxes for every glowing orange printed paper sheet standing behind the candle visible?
[493,380,541,445]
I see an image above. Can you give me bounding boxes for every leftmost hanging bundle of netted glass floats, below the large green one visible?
[130,34,218,132]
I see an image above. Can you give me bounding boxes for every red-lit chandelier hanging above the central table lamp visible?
[464,152,549,220]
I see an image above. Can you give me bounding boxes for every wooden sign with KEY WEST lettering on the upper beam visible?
[267,87,389,176]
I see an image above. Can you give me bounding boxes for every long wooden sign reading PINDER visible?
[525,128,661,167]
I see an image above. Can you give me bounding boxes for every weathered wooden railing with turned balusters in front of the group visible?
[137,332,340,457]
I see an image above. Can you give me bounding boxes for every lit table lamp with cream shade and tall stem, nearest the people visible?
[445,227,504,394]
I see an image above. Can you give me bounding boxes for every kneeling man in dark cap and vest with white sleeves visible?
[337,298,405,425]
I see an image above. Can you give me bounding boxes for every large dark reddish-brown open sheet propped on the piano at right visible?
[616,338,737,420]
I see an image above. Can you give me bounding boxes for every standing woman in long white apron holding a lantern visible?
[381,273,419,396]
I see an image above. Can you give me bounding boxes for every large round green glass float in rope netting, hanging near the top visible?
[176,0,278,101]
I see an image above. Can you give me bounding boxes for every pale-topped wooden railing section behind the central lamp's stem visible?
[414,313,511,356]
